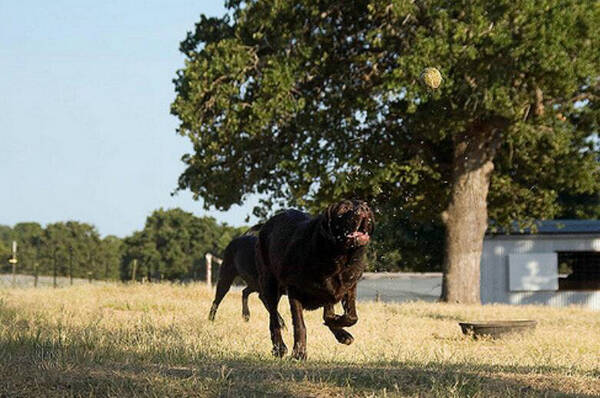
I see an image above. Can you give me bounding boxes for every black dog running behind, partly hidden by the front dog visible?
[208,230,285,327]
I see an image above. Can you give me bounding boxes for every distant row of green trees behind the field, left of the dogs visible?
[0,209,245,281]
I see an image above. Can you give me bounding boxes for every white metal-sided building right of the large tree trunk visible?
[481,220,600,310]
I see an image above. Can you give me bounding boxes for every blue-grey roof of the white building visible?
[487,220,600,235]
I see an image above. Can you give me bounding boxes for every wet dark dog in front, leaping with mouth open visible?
[256,200,374,359]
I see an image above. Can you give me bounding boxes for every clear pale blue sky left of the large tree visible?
[0,0,255,236]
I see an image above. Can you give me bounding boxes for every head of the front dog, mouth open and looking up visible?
[323,200,375,249]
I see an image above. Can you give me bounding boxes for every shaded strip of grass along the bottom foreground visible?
[0,302,600,397]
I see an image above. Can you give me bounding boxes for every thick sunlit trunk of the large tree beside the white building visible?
[441,126,499,304]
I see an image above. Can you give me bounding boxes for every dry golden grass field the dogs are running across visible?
[0,284,600,397]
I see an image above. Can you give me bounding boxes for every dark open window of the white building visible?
[558,251,600,290]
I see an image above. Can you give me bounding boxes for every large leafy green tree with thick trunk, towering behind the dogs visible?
[172,0,600,303]
